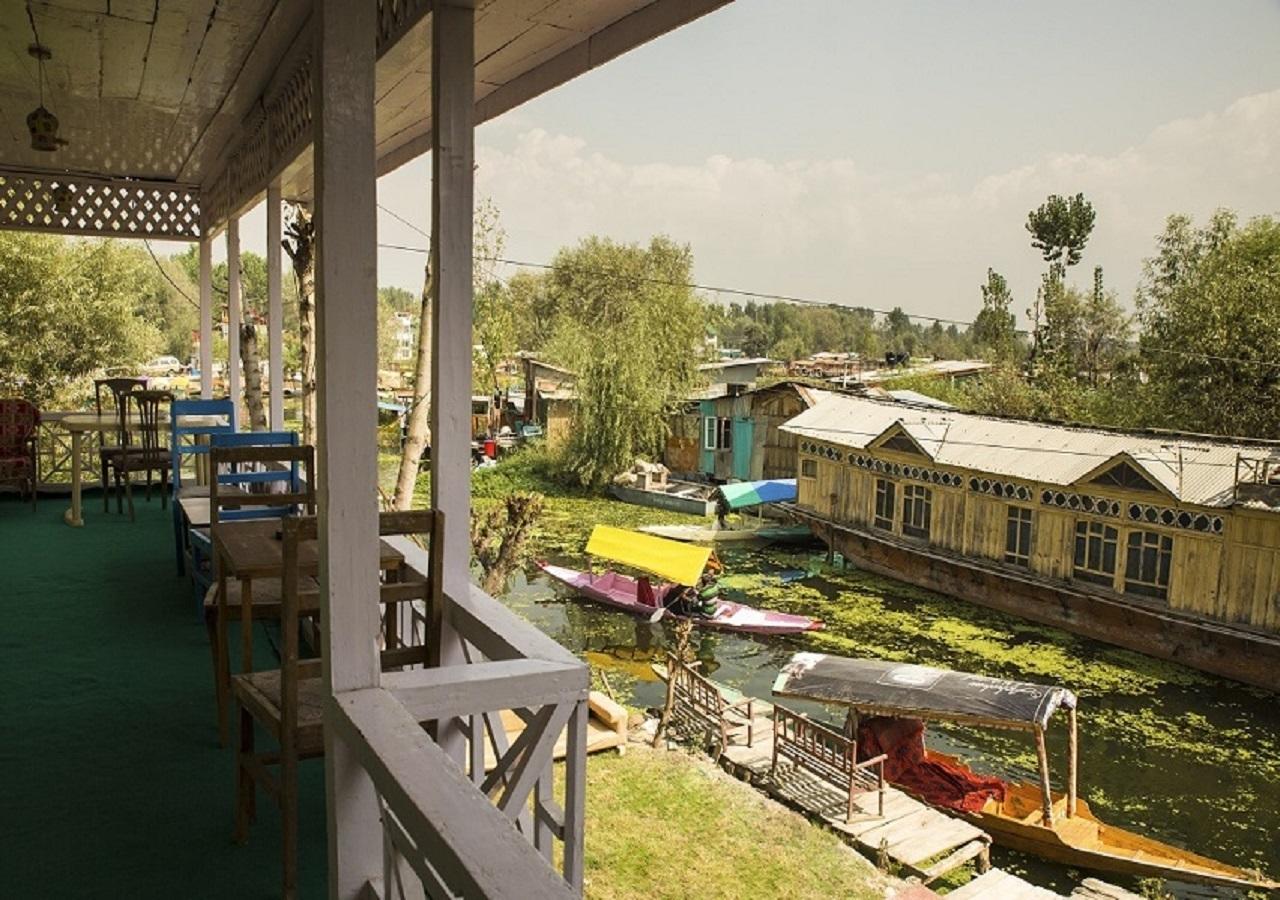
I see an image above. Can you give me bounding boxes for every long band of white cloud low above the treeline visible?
[477,91,1280,325]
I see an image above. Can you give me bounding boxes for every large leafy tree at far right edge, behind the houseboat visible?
[1138,211,1280,438]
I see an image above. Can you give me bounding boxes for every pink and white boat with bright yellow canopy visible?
[538,525,822,634]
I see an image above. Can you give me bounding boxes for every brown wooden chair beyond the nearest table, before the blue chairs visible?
[200,431,316,745]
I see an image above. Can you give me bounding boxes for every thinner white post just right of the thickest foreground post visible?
[431,1,475,764]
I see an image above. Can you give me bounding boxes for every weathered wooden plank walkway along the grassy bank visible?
[723,722,991,883]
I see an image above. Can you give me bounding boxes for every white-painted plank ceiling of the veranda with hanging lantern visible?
[0,0,728,232]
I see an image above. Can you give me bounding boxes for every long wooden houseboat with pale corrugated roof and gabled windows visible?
[781,396,1280,690]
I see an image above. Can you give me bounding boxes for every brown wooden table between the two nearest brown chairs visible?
[210,518,404,744]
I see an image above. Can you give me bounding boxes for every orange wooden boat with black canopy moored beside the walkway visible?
[773,653,1280,890]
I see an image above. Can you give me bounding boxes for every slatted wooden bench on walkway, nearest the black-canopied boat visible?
[771,705,886,822]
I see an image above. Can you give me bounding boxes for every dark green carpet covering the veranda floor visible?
[0,494,325,897]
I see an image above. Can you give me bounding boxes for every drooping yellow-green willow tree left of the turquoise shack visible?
[547,237,704,488]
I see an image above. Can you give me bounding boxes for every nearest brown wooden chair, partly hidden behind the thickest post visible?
[232,510,444,897]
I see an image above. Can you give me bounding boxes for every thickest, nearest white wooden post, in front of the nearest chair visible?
[312,0,383,900]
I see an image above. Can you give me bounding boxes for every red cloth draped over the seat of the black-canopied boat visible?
[858,716,1005,812]
